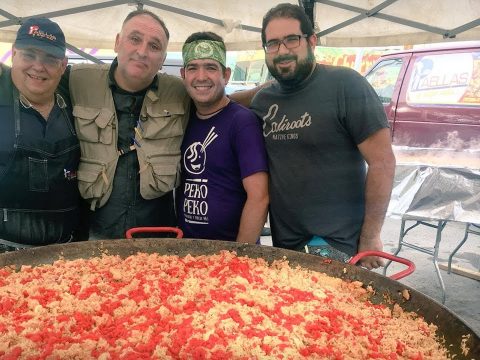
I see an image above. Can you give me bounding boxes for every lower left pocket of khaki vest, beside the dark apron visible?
[77,159,110,200]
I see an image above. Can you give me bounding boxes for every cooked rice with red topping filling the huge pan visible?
[0,251,448,360]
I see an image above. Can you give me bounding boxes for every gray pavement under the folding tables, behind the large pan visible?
[261,218,480,336]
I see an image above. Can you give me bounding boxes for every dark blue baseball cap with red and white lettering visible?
[14,18,66,59]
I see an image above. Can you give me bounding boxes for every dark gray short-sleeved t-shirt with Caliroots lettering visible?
[251,65,388,254]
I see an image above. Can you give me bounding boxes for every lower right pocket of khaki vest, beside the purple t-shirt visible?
[140,155,180,200]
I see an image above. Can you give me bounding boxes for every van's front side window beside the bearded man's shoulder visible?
[366,59,403,104]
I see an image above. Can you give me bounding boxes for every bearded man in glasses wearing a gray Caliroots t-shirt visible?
[251,4,395,269]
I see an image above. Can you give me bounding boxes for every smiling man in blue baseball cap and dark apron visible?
[0,18,80,251]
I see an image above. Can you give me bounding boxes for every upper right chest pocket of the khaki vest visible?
[140,103,185,139]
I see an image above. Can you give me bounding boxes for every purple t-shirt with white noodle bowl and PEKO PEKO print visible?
[177,102,268,240]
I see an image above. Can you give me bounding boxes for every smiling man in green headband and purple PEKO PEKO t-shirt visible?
[178,32,268,243]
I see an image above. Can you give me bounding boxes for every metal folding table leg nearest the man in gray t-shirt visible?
[383,218,447,304]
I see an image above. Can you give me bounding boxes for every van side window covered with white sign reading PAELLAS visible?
[407,52,480,106]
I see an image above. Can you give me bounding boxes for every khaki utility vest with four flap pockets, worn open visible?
[69,64,190,210]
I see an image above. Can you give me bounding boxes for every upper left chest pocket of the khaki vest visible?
[73,105,114,144]
